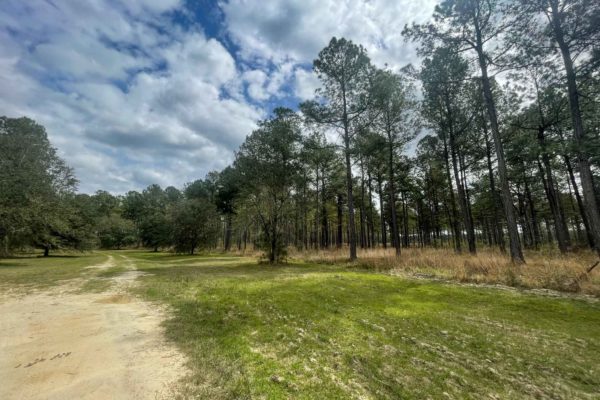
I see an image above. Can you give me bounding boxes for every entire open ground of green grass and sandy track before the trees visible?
[0,251,600,399]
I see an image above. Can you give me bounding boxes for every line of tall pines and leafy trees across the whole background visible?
[0,0,600,264]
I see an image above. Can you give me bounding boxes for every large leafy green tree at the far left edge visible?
[0,117,77,255]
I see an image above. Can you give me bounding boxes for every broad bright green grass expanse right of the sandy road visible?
[127,252,600,399]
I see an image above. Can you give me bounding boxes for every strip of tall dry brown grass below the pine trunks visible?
[292,248,600,296]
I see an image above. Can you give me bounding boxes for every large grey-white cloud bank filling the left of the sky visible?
[0,0,263,192]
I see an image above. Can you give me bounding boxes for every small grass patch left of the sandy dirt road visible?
[0,252,106,290]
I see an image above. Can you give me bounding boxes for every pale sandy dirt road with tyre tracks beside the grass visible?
[0,256,186,400]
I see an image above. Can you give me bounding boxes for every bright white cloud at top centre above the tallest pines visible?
[221,0,437,66]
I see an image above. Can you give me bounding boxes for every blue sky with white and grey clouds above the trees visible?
[0,0,436,194]
